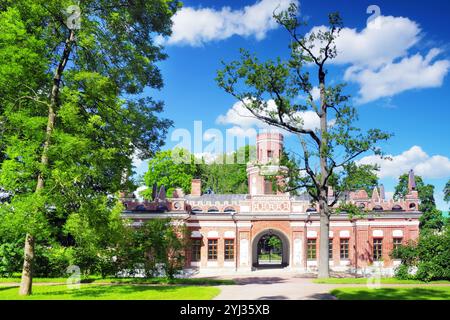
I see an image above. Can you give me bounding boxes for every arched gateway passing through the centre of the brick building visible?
[252,229,290,268]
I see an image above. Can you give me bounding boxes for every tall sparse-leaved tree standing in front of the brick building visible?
[216,4,390,278]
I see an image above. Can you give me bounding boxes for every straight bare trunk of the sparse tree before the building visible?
[318,66,330,278]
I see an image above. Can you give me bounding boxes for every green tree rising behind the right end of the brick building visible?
[394,173,444,232]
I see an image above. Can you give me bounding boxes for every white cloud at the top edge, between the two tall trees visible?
[162,0,298,46]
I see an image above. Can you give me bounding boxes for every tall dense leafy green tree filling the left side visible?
[0,0,179,295]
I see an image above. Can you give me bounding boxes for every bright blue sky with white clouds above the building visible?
[136,0,450,210]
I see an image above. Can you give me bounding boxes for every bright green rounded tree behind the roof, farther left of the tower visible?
[142,149,196,199]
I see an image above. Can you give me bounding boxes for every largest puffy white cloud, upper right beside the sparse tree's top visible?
[310,16,450,103]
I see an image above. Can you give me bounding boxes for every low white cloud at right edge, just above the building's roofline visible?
[358,146,450,179]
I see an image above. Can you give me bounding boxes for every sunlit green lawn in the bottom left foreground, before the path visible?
[0,284,220,300]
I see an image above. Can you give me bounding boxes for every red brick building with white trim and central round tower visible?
[123,133,421,274]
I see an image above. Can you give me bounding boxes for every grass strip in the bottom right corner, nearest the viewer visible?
[330,287,450,300]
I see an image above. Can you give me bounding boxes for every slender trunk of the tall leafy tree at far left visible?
[19,30,75,295]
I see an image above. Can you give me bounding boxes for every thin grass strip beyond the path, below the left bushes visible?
[0,276,235,286]
